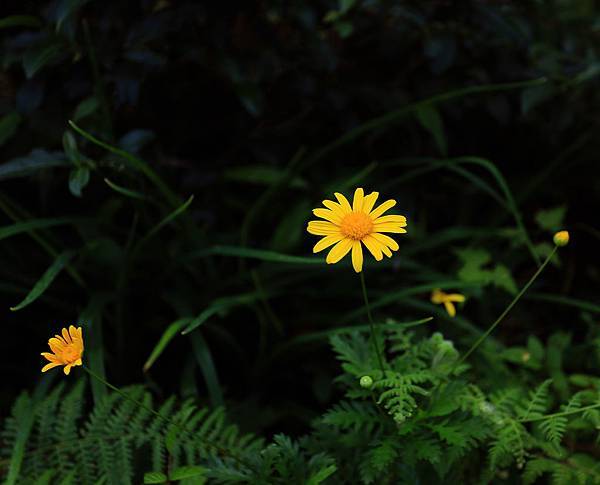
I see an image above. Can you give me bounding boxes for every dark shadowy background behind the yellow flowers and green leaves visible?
[0,0,600,432]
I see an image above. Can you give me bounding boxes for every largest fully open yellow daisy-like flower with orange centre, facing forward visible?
[307,188,406,273]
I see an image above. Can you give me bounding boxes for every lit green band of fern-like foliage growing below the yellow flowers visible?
[2,324,600,485]
